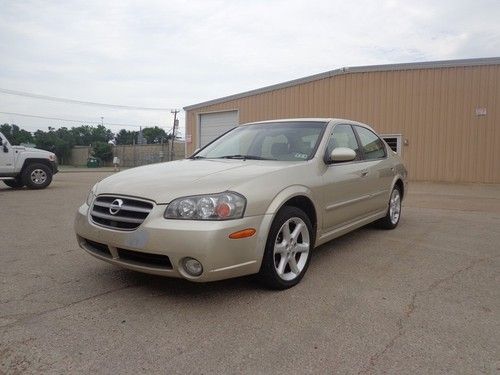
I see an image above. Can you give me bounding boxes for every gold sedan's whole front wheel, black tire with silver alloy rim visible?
[257,206,315,290]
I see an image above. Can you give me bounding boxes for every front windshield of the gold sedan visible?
[192,121,326,161]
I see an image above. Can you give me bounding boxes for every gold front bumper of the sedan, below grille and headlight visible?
[75,204,272,282]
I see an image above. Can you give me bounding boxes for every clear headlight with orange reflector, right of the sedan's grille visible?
[163,192,247,220]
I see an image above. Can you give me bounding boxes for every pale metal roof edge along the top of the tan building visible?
[183,57,500,111]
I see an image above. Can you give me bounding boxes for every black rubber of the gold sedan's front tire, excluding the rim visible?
[259,206,315,289]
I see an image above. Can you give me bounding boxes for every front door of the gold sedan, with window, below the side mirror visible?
[322,124,371,232]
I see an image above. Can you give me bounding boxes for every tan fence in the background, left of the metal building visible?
[67,142,185,167]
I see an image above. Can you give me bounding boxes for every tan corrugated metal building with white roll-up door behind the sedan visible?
[184,57,500,183]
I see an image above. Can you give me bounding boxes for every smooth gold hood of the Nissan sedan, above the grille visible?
[96,159,297,204]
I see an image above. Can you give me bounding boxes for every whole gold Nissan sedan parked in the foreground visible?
[75,118,407,289]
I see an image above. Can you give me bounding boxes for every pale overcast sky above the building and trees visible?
[0,0,500,138]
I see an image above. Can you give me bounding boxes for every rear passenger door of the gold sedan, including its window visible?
[353,125,394,215]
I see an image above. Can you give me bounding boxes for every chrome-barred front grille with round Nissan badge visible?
[90,195,153,230]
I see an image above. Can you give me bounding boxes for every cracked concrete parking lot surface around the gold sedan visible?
[0,172,500,374]
